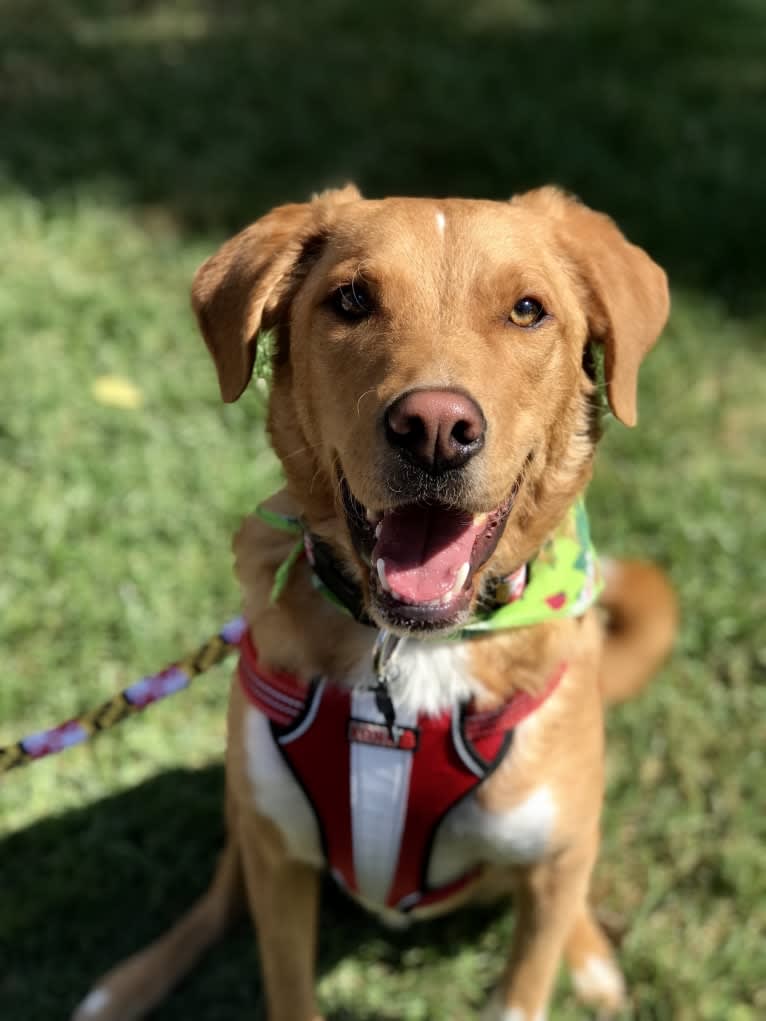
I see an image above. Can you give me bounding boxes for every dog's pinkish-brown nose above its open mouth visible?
[385,390,486,474]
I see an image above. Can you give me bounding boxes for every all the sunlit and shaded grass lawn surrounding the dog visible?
[0,0,766,1021]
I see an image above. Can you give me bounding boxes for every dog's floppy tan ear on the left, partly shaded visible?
[191,185,361,402]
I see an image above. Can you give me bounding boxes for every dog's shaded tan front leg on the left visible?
[239,814,321,1021]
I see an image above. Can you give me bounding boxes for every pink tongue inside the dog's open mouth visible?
[373,506,481,603]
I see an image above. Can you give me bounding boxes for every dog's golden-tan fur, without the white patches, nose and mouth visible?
[76,188,676,1021]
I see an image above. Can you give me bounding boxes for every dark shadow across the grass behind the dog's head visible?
[0,0,766,311]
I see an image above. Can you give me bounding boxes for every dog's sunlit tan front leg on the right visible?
[483,838,597,1021]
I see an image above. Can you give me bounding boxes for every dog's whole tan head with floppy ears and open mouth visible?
[192,187,668,631]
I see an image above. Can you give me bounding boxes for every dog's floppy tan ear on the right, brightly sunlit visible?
[514,188,670,426]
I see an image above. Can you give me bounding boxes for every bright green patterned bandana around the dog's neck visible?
[255,499,604,638]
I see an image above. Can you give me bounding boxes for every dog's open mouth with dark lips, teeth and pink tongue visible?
[341,479,519,631]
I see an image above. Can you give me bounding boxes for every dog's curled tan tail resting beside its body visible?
[599,558,678,704]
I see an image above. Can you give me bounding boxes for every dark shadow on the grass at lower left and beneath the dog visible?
[0,768,497,1021]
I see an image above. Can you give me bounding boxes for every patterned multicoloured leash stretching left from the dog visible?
[0,617,245,775]
